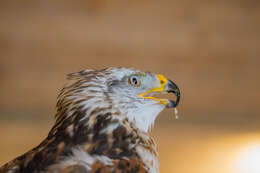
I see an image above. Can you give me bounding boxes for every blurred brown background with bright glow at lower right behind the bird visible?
[0,0,260,173]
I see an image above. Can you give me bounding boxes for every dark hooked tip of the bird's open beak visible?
[165,80,181,108]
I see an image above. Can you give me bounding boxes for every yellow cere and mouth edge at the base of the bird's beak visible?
[139,74,167,105]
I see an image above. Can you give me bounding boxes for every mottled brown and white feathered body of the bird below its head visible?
[0,113,157,173]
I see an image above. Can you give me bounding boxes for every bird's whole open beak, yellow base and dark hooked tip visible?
[139,74,181,108]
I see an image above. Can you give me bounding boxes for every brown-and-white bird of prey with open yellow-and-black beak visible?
[0,67,180,173]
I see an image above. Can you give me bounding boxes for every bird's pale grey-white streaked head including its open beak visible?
[57,68,180,131]
